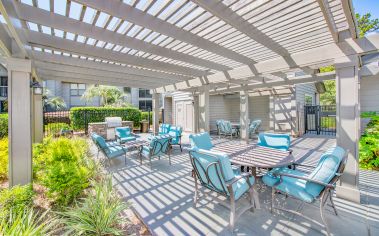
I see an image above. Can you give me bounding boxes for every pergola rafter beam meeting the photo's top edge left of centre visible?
[73,0,253,65]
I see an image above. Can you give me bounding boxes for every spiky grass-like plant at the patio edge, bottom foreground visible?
[58,178,128,235]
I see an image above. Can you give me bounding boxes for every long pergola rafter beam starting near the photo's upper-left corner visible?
[16,3,231,71]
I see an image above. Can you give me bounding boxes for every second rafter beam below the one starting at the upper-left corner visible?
[29,50,186,83]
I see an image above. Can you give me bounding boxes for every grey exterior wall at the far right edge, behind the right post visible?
[360,75,379,111]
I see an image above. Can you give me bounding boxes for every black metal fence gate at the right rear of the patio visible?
[304,105,336,135]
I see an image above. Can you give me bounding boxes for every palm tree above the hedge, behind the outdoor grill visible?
[82,85,129,106]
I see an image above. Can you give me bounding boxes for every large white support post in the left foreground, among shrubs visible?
[7,58,32,186]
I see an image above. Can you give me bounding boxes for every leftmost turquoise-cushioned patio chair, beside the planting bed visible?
[91,133,126,166]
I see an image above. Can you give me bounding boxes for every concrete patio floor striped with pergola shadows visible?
[96,136,379,236]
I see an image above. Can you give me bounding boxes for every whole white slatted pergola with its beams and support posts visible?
[0,0,379,201]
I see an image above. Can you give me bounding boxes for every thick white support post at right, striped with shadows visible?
[336,57,360,203]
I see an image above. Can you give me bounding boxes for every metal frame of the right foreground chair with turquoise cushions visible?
[271,151,349,236]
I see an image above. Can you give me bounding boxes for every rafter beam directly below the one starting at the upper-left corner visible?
[25,30,209,76]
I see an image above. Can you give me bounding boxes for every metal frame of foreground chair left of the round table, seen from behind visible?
[189,151,259,231]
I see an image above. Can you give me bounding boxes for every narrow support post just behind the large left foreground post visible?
[32,94,43,143]
